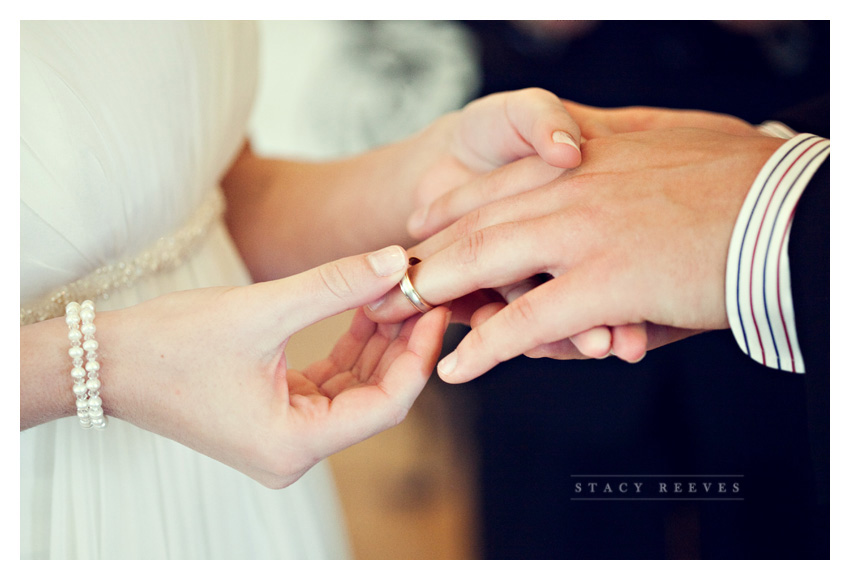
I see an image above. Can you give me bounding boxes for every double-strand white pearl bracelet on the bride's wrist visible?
[65,300,107,429]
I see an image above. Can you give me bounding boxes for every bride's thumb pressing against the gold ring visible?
[271,246,408,333]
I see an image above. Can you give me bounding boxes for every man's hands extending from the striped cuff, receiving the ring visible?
[370,103,782,382]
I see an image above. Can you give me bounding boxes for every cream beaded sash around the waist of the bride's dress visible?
[21,188,225,326]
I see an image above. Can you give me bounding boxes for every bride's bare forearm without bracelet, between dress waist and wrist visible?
[223,130,442,280]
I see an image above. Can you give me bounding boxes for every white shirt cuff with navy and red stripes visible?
[726,130,829,373]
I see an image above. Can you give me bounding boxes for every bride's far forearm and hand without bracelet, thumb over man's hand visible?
[223,89,581,281]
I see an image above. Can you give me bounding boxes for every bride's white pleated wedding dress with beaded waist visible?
[20,22,347,559]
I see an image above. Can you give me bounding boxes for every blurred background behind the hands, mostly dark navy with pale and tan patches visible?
[245,21,830,559]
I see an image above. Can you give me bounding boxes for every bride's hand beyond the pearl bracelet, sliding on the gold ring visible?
[98,247,448,488]
